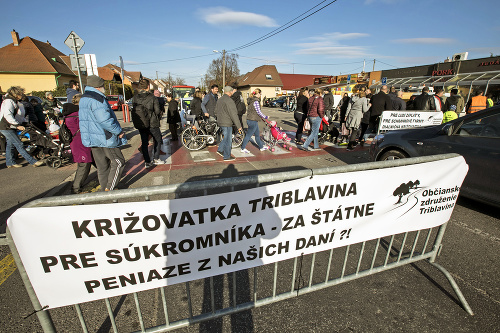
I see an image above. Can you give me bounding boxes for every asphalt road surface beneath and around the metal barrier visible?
[0,109,500,332]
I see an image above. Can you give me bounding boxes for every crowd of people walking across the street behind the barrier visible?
[0,76,493,193]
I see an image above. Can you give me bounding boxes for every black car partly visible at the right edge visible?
[370,106,500,207]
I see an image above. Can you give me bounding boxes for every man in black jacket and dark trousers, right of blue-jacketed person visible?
[132,79,165,168]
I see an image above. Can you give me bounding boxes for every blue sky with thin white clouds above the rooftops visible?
[0,0,500,85]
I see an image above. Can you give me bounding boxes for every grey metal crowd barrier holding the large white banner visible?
[7,154,473,332]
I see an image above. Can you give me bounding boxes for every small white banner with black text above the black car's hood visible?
[379,111,443,132]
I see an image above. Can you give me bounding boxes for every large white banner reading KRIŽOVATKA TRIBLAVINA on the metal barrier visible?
[8,157,468,308]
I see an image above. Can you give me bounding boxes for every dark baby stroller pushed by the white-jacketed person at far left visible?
[18,124,72,169]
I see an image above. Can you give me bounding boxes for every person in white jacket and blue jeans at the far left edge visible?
[0,87,43,168]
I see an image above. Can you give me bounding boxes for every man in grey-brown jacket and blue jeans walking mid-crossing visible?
[215,86,241,161]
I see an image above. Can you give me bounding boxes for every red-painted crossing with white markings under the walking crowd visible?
[56,108,369,195]
